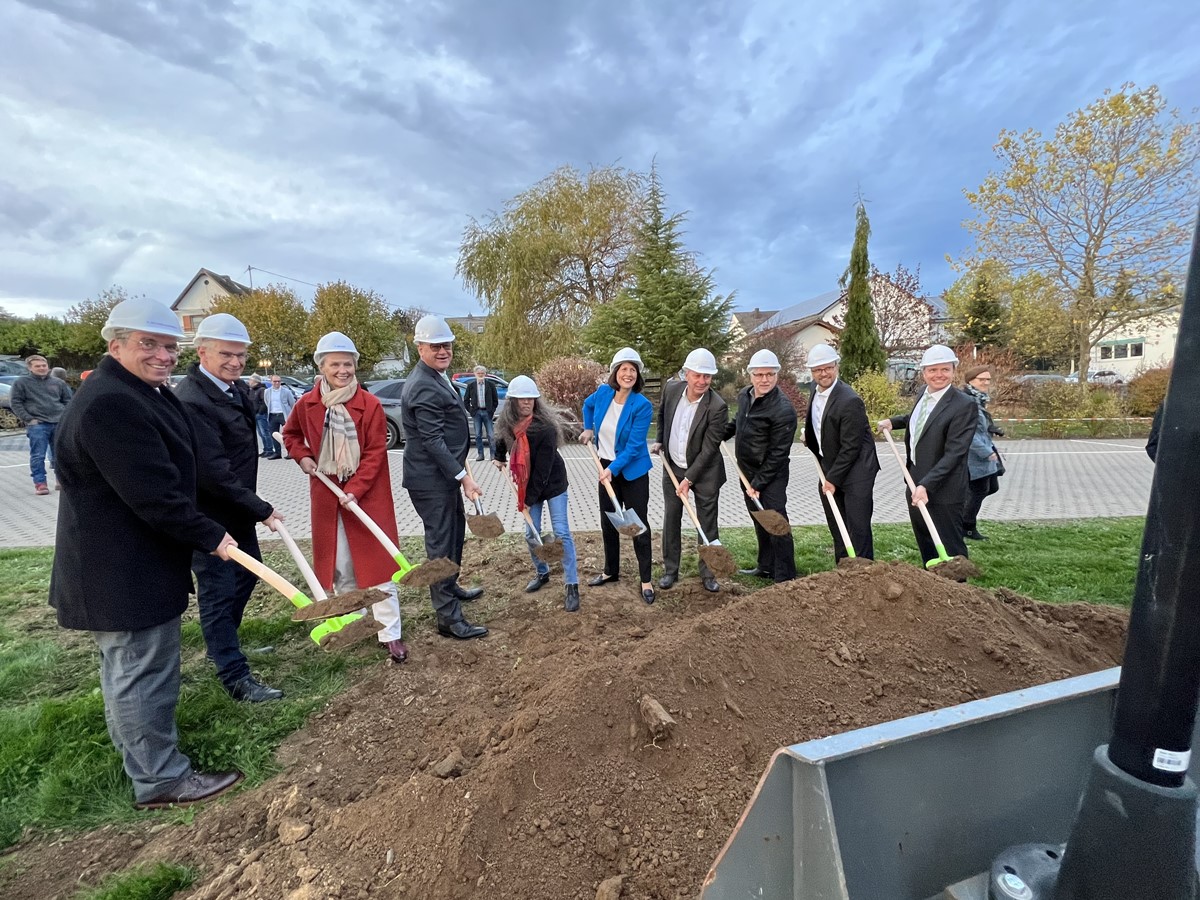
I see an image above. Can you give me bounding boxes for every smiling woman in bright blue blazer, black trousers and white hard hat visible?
[580,347,654,604]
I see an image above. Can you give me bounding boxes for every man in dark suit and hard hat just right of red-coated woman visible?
[401,316,487,640]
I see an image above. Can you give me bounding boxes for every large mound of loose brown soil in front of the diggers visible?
[4,535,1126,900]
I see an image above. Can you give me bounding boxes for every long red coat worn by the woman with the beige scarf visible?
[283,388,400,590]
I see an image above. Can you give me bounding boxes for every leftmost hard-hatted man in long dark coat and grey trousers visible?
[50,298,241,809]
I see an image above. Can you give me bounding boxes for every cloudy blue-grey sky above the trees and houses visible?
[0,0,1200,316]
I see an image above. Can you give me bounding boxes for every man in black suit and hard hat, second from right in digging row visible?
[804,343,880,559]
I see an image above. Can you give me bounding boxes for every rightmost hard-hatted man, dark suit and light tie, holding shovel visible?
[880,343,977,563]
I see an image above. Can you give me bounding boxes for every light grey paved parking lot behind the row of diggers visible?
[0,434,1153,547]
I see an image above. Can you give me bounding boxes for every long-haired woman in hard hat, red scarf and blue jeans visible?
[494,376,580,612]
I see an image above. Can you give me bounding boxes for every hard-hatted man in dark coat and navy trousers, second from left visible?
[175,313,283,703]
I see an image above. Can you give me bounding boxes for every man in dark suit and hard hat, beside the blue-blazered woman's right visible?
[650,348,730,593]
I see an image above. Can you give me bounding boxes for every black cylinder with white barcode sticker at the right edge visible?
[1109,213,1200,787]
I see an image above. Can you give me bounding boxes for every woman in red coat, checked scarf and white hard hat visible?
[283,331,408,662]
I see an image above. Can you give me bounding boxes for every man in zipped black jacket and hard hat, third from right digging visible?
[726,350,796,582]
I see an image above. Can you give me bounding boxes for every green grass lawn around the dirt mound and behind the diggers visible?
[0,518,1142,883]
